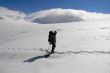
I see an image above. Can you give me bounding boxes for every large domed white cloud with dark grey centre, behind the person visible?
[28,8,110,24]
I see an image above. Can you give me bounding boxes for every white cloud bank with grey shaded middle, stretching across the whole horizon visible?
[0,7,110,24]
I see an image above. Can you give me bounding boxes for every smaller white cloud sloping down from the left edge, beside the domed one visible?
[0,7,26,21]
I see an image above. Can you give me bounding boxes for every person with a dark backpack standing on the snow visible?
[48,31,57,53]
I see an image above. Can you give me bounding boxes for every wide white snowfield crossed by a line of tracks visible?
[0,6,110,73]
